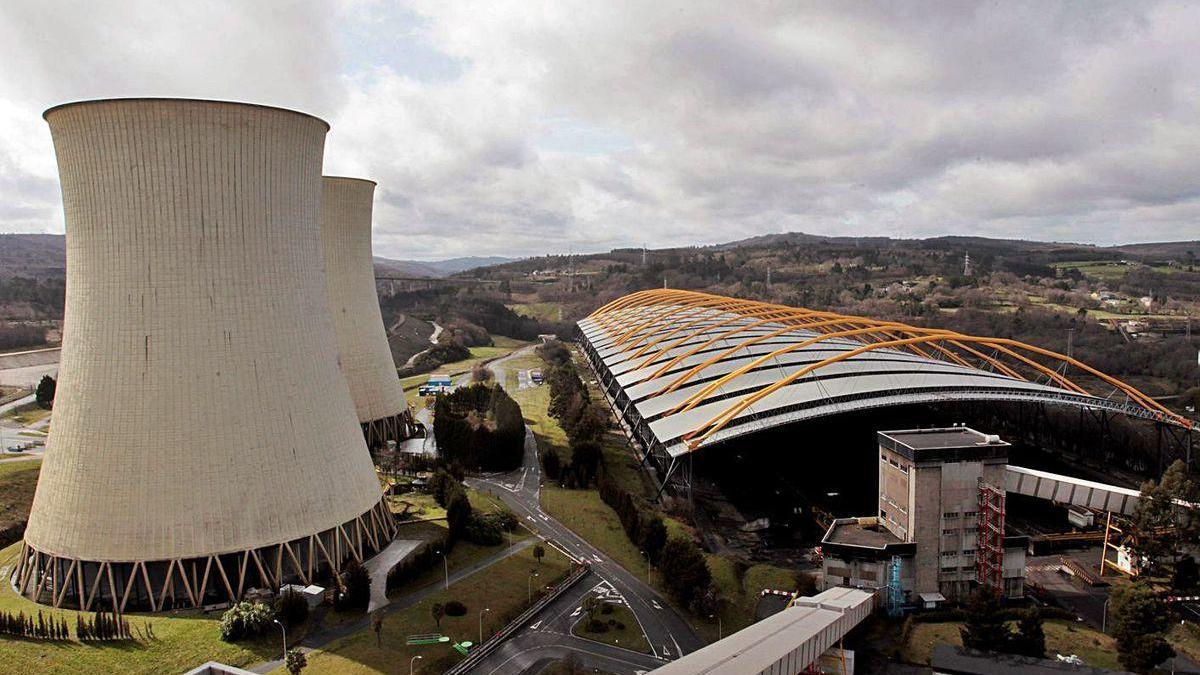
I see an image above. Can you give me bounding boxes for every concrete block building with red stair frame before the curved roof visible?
[822,426,1028,598]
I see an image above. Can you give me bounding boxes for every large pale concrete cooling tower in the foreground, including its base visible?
[16,98,394,610]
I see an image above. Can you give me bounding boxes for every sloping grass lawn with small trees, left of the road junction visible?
[291,546,570,675]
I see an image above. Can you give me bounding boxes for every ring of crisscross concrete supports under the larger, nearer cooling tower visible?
[12,500,396,613]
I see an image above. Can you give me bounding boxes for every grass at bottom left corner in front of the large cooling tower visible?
[0,543,280,673]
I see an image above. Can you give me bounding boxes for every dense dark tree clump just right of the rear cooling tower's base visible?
[433,384,524,471]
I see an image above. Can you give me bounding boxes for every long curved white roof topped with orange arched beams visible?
[580,289,1192,458]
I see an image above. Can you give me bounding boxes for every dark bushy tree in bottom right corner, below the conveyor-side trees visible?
[1111,583,1175,673]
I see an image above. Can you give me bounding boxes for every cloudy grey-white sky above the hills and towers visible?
[0,0,1200,259]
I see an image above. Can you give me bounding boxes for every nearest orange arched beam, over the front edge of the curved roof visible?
[684,335,1192,450]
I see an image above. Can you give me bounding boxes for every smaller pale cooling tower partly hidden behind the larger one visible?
[320,175,412,448]
